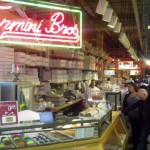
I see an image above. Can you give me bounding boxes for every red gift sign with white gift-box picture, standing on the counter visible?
[0,101,18,126]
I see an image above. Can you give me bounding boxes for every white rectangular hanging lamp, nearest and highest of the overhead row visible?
[95,0,108,15]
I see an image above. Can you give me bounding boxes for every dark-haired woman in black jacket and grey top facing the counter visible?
[123,82,140,150]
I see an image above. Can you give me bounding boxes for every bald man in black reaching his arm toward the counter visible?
[122,89,150,150]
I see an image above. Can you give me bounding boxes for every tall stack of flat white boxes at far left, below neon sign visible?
[0,47,14,81]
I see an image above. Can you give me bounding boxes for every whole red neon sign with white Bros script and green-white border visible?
[0,1,82,48]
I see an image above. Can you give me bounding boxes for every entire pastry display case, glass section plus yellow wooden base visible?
[0,110,128,150]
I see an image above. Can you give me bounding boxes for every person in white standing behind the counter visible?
[85,79,100,108]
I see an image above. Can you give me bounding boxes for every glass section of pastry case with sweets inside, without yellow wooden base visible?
[0,110,112,149]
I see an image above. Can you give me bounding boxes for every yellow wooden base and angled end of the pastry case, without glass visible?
[16,111,128,150]
